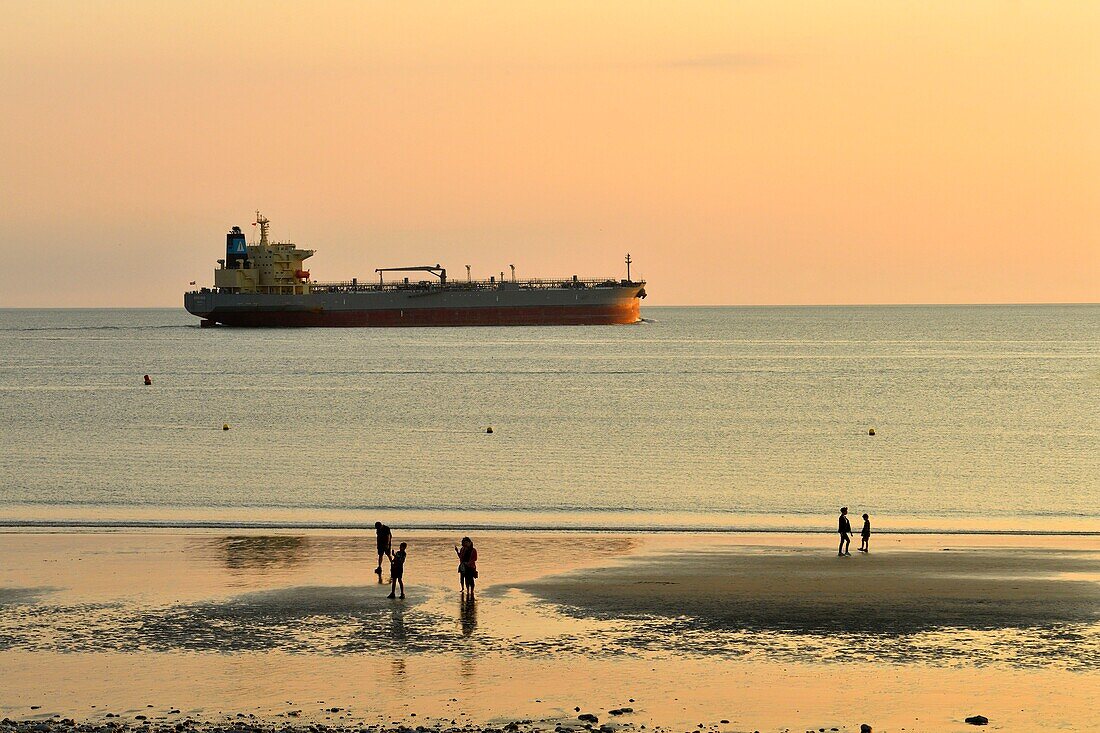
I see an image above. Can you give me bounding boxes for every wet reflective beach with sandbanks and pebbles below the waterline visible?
[0,530,1100,732]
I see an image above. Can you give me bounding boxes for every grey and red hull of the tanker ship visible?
[184,285,642,327]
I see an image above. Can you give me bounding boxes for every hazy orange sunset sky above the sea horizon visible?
[0,0,1100,306]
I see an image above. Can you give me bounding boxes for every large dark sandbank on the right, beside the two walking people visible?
[517,540,1100,634]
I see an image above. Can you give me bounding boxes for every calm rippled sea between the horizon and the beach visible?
[0,306,1100,532]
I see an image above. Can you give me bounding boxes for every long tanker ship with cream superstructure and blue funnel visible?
[184,211,646,327]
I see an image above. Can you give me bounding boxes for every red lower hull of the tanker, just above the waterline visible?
[206,298,640,327]
